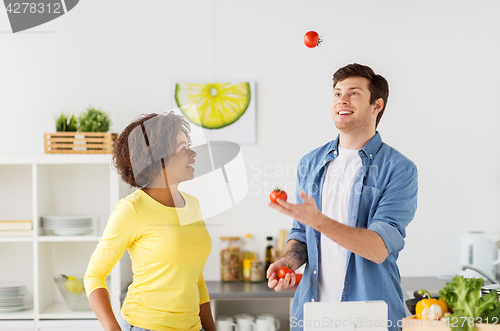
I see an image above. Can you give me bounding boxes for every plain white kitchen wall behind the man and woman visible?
[0,0,500,279]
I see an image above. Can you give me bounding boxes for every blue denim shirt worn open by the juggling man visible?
[287,132,417,331]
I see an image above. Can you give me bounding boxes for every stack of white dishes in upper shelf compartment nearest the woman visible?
[42,216,92,236]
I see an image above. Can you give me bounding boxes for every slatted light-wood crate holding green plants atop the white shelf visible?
[43,132,118,154]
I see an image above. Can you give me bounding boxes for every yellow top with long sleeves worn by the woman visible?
[84,190,212,331]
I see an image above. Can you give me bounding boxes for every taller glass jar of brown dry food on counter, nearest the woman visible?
[220,237,241,282]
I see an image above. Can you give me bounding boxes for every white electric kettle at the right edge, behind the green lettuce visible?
[460,232,500,280]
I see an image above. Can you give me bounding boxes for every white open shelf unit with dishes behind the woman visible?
[0,154,135,330]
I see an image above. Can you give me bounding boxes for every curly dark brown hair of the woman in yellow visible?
[112,111,191,188]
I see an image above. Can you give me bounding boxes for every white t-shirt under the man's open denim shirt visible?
[318,146,361,302]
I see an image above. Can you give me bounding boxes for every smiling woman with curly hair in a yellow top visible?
[84,112,215,331]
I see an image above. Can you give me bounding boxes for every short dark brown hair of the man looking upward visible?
[333,63,389,128]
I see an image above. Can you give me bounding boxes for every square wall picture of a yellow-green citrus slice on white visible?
[173,82,255,144]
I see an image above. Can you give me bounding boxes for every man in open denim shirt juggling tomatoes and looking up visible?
[267,64,417,330]
